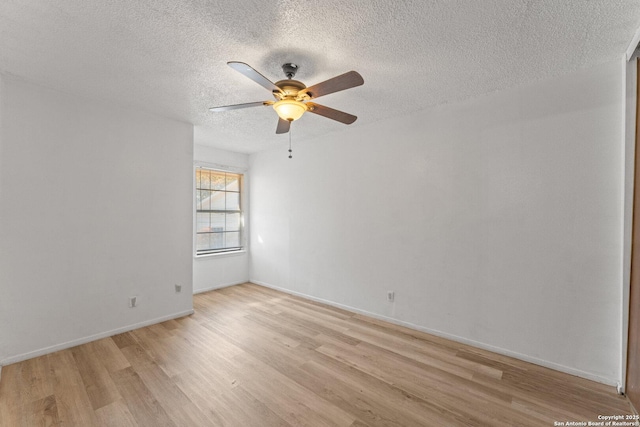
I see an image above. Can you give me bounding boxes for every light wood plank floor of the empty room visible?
[0,284,631,427]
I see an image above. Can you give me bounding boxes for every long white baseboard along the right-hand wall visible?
[249,279,617,387]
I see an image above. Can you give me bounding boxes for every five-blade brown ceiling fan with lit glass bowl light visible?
[209,61,364,133]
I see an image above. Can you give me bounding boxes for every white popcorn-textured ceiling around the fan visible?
[0,0,640,152]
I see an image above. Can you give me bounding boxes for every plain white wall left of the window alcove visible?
[0,76,193,364]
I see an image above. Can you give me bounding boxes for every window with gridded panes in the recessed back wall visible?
[196,168,242,255]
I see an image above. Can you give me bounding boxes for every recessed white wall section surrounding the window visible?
[192,145,249,293]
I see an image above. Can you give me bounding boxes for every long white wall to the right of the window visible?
[250,61,624,384]
